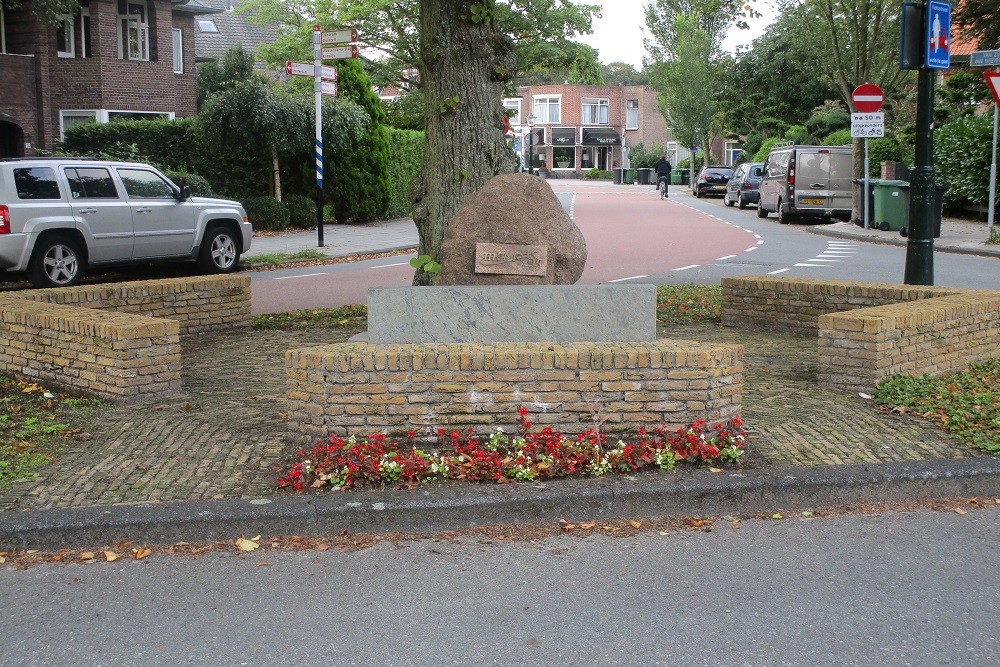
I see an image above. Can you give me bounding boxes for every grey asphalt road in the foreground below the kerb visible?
[0,507,1000,667]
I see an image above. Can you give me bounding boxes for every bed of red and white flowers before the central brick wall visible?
[278,407,746,491]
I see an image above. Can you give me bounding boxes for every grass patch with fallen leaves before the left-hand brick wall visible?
[0,373,105,489]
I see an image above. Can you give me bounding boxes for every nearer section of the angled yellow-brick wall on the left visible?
[0,296,181,403]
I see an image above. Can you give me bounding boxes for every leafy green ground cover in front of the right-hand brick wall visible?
[873,359,1000,454]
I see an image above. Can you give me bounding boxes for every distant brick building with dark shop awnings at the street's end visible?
[503,84,690,177]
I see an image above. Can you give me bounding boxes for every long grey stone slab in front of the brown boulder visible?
[366,285,656,344]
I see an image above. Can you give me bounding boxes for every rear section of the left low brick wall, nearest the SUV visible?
[16,275,250,336]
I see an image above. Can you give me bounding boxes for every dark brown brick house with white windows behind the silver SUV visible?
[0,0,219,157]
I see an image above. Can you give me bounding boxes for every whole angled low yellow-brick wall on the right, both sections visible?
[722,276,1000,391]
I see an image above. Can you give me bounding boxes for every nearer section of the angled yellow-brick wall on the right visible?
[818,291,1000,391]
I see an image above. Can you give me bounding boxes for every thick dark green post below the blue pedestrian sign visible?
[903,46,936,285]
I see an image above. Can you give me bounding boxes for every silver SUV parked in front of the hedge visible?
[0,158,252,287]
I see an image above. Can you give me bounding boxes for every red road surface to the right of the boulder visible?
[554,185,758,285]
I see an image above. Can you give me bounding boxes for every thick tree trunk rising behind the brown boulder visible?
[411,0,516,285]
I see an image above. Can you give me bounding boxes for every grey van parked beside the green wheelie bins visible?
[757,144,854,224]
